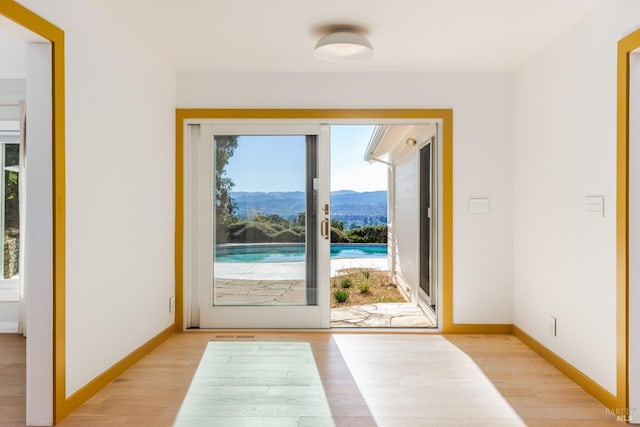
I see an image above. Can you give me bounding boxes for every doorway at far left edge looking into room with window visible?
[0,8,56,425]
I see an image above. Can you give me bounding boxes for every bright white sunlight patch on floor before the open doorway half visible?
[333,334,526,427]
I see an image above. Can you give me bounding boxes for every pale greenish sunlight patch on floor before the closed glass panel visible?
[174,341,334,427]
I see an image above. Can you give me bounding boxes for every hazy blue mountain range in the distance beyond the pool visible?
[231,190,387,229]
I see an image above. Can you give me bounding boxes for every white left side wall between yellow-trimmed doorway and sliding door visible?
[21,0,175,395]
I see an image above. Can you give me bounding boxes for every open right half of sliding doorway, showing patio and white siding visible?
[331,125,436,328]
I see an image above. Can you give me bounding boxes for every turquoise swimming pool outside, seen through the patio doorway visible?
[215,243,387,262]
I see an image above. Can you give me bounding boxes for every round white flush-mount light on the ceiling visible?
[316,28,373,61]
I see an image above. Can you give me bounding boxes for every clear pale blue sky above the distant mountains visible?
[226,125,387,192]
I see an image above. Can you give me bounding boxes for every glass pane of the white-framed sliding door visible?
[213,135,317,306]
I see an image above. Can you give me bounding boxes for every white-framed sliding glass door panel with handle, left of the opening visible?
[186,124,330,328]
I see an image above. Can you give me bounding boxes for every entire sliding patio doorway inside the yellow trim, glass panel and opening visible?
[179,119,443,329]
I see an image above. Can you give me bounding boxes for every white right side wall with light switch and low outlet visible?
[514,0,640,393]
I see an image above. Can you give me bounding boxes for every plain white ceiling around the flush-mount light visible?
[92,0,603,71]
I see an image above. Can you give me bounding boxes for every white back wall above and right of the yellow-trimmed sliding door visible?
[177,72,512,323]
